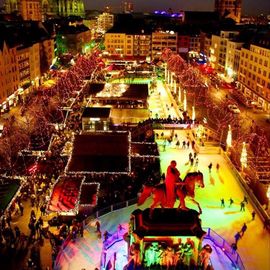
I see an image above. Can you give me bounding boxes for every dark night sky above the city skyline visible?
[0,0,270,15]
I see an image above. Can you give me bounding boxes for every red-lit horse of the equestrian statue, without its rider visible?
[138,172,204,214]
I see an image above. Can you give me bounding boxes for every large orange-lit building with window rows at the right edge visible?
[238,43,270,110]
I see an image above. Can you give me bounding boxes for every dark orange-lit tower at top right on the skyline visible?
[215,0,242,23]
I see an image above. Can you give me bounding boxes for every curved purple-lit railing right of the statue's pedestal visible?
[203,228,245,270]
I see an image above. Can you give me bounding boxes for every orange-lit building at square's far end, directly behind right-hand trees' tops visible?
[152,31,178,59]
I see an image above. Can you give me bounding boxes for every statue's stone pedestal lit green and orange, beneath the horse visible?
[127,208,206,269]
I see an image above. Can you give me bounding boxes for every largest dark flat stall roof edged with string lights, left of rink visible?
[66,132,131,175]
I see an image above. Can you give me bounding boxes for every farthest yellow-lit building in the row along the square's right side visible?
[210,31,239,73]
